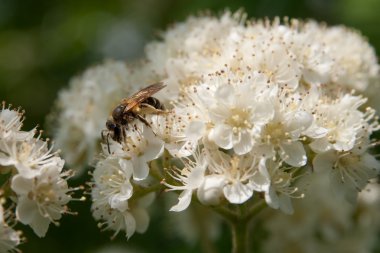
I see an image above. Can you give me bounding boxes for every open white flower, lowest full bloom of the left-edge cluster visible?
[11,165,71,237]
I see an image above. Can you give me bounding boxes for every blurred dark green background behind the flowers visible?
[0,0,380,253]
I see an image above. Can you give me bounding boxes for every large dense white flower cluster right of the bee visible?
[154,13,380,213]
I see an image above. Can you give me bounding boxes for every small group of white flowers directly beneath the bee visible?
[92,124,164,238]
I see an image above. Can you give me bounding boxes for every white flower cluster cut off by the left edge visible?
[0,103,72,246]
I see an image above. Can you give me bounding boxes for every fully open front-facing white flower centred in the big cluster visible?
[209,80,273,154]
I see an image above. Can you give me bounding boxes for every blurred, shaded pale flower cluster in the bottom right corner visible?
[262,175,380,253]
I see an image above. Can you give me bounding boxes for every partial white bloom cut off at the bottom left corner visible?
[0,204,21,252]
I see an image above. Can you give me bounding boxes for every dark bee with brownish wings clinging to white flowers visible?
[102,82,166,153]
